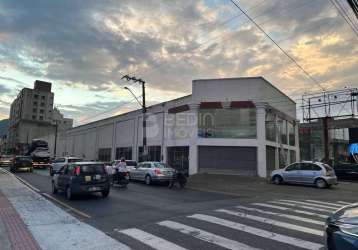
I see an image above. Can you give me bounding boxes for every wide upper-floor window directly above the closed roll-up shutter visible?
[198,108,256,138]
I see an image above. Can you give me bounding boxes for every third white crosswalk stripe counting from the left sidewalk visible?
[188,214,324,250]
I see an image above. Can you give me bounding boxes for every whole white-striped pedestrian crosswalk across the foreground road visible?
[116,199,356,250]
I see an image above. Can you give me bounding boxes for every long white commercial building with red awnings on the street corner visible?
[53,77,299,177]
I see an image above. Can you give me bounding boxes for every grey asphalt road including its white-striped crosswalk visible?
[6,170,358,250]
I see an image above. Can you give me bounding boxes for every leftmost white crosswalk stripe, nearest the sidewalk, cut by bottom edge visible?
[118,228,186,250]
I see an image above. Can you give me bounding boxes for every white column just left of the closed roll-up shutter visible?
[189,103,200,175]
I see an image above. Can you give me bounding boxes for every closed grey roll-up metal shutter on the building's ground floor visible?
[198,146,257,176]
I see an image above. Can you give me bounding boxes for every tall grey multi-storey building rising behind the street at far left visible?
[7,80,73,152]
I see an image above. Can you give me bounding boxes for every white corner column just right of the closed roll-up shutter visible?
[256,102,267,177]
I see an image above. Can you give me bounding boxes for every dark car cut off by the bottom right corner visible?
[326,203,358,250]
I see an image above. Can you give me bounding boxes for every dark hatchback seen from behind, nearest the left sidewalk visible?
[52,162,110,200]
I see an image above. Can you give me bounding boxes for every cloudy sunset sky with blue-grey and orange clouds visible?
[0,0,358,125]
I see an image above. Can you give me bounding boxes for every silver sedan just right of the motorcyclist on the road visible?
[129,161,175,185]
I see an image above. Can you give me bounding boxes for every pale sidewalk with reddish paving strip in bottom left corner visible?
[0,168,129,250]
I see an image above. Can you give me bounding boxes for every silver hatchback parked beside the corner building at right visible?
[271,161,338,188]
